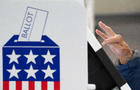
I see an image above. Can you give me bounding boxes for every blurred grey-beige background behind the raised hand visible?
[86,0,140,63]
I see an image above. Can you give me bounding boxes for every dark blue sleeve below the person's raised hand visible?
[117,51,140,90]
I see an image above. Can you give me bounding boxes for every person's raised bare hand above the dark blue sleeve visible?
[96,21,133,64]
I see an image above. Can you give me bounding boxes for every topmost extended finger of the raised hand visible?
[98,21,115,36]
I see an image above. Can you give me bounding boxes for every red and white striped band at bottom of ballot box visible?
[3,81,60,90]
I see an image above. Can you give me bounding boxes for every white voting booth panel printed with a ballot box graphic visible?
[0,0,88,90]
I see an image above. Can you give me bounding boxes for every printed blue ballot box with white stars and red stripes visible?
[3,35,60,90]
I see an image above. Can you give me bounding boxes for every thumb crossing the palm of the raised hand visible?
[102,34,123,45]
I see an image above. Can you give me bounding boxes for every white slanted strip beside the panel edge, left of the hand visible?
[87,28,102,52]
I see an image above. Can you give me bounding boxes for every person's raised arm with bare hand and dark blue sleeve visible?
[96,22,140,90]
